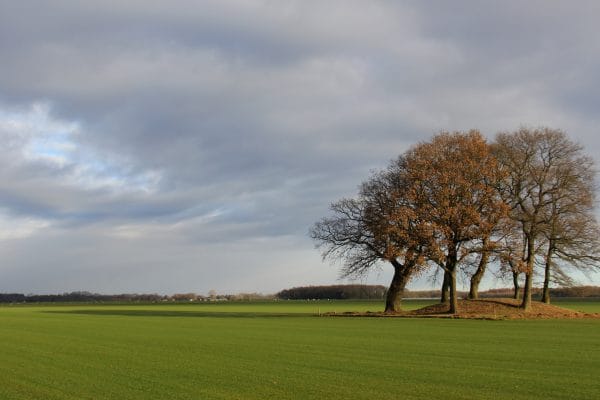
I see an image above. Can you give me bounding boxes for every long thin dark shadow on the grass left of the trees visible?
[41,310,314,318]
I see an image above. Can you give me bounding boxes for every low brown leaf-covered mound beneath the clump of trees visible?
[328,299,600,319]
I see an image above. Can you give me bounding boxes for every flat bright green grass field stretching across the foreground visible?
[0,301,600,400]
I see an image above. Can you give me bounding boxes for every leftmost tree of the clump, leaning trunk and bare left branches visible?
[310,158,430,313]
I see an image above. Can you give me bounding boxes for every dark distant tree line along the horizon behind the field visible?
[0,285,600,303]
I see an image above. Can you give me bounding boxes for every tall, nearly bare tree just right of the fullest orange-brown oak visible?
[494,128,593,309]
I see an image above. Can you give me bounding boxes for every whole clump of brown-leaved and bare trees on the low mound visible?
[310,128,600,313]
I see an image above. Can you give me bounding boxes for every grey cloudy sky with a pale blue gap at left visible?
[0,0,600,294]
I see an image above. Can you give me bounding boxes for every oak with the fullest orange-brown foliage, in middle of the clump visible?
[405,130,507,313]
